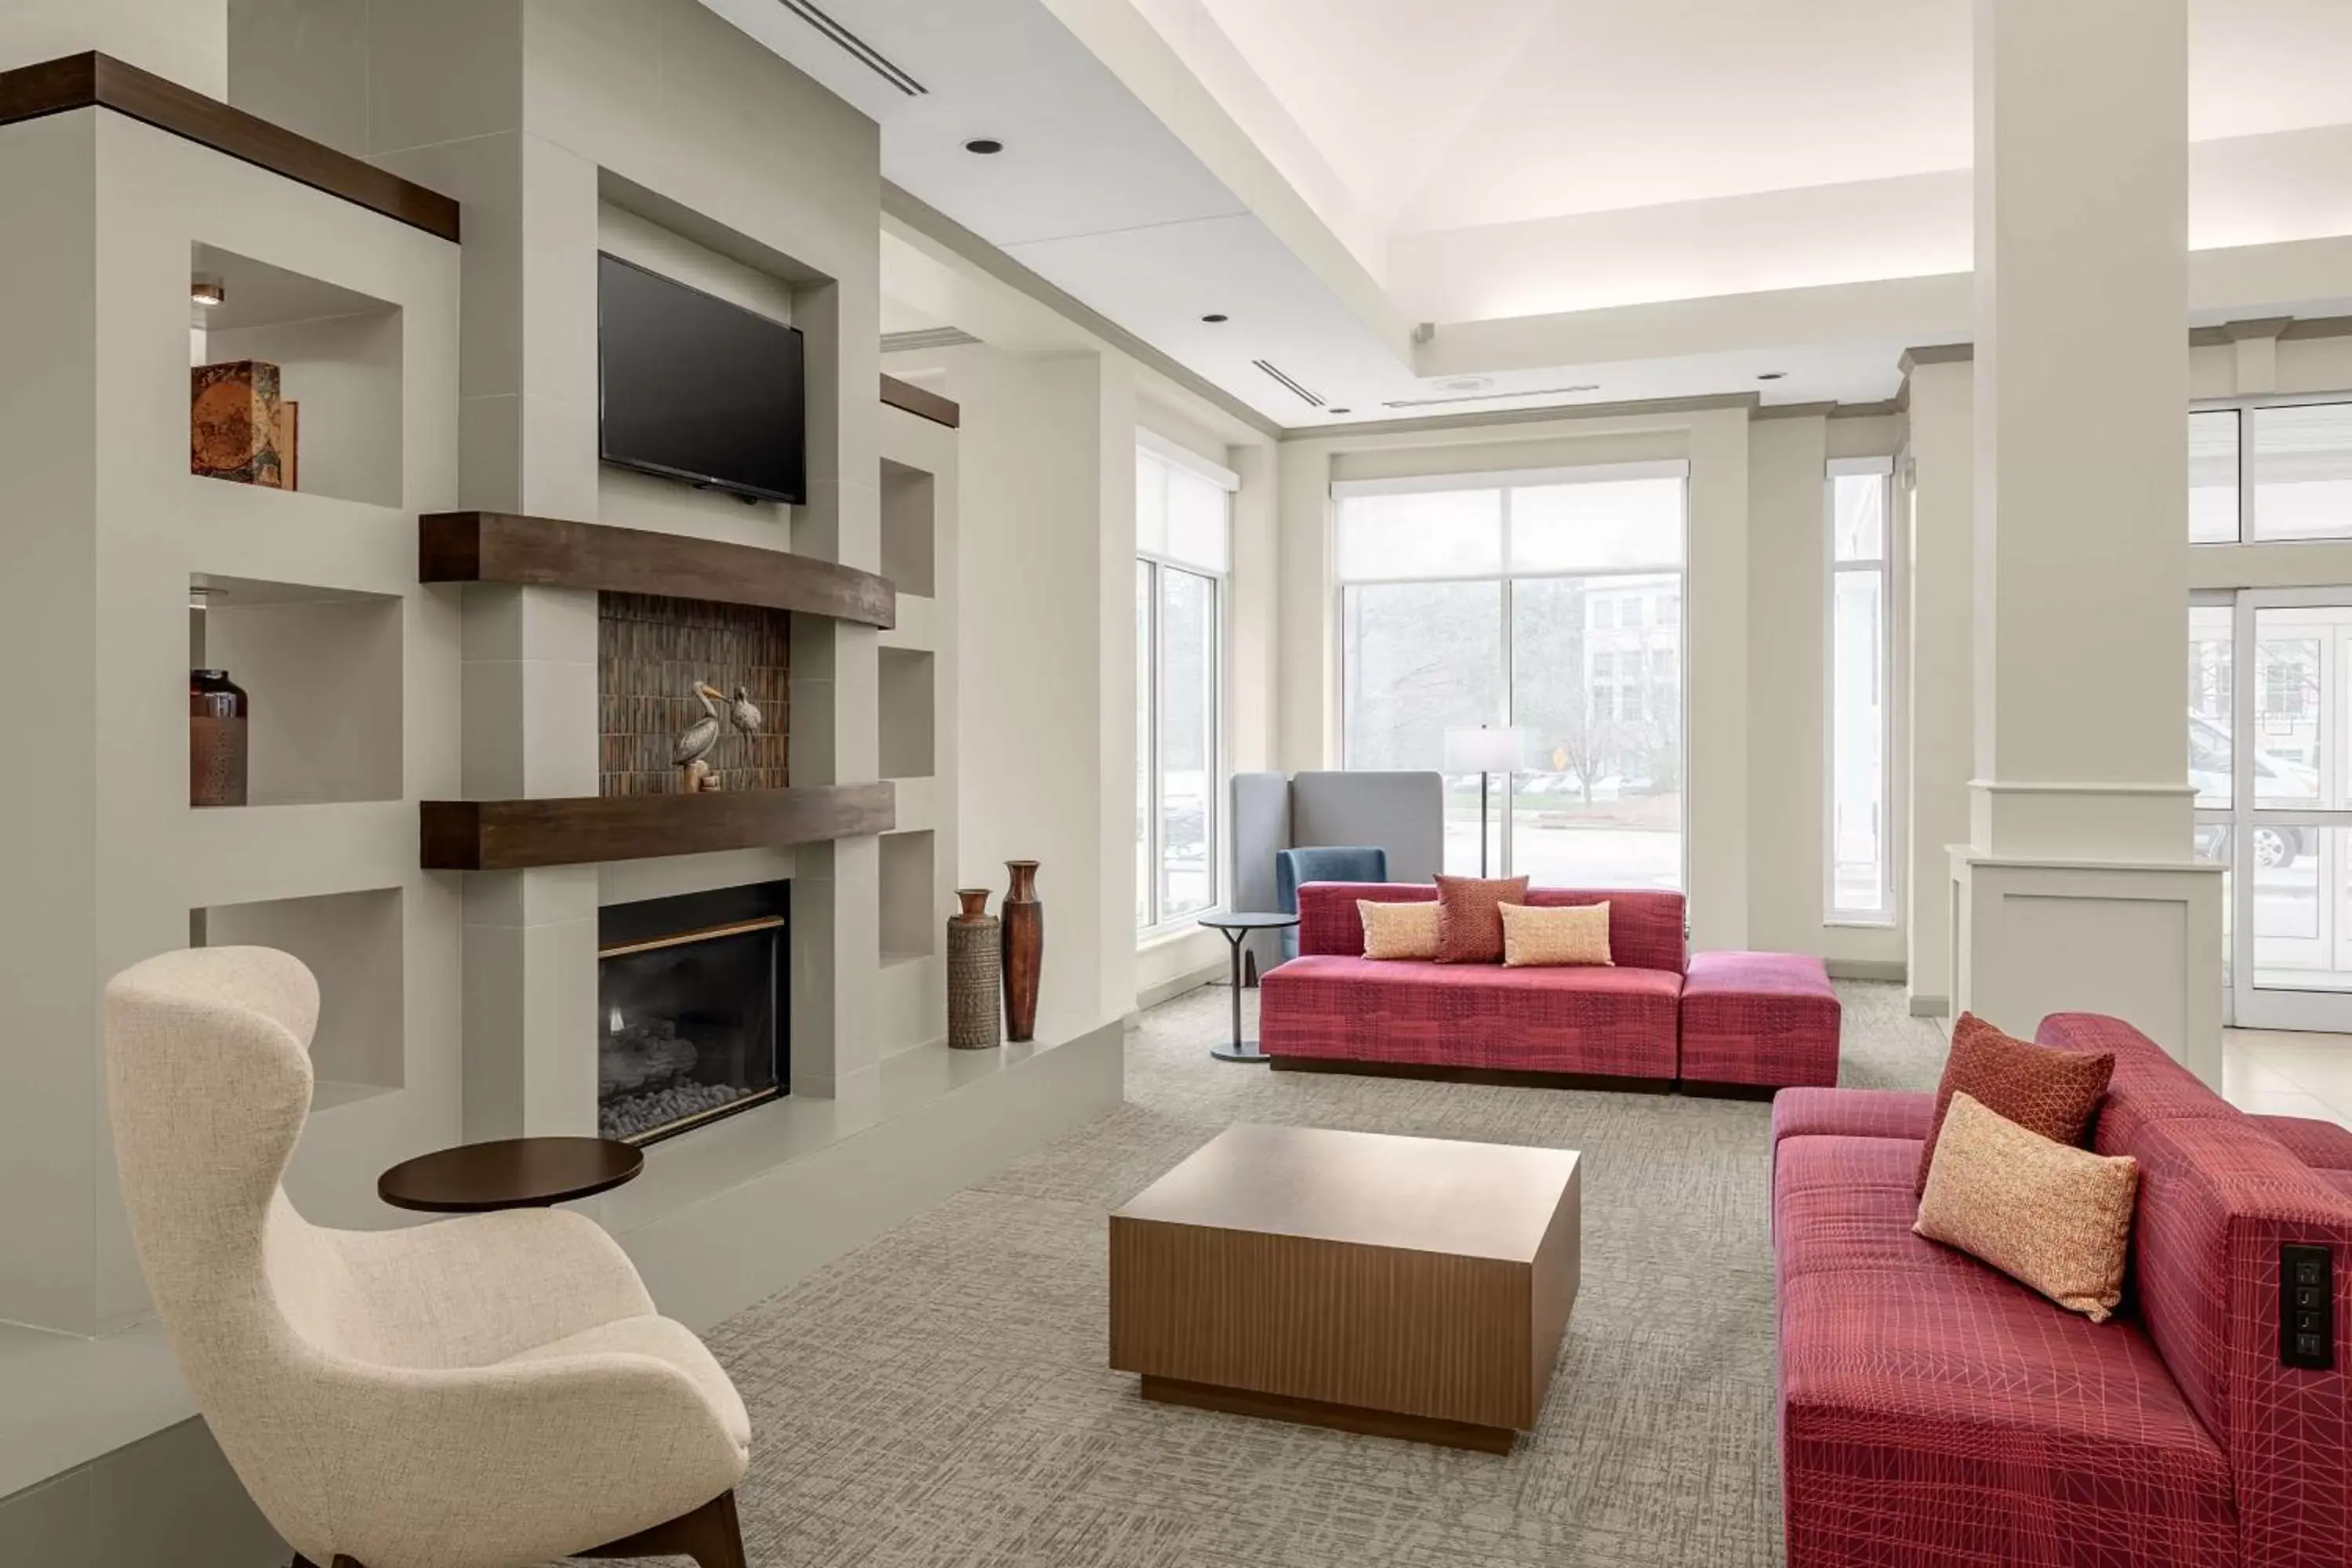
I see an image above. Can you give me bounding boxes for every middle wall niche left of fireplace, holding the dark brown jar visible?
[188,574,402,808]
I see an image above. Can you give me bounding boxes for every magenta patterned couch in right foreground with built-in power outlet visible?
[1771,1013,2352,1568]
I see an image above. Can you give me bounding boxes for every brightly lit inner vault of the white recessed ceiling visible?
[1185,0,2352,233]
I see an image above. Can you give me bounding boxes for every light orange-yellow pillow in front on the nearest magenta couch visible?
[1912,1093,2140,1323]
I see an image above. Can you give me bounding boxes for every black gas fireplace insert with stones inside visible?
[597,881,790,1142]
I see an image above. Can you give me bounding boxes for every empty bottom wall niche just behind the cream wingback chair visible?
[188,888,405,1102]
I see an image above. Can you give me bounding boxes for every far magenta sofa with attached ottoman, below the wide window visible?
[1258,881,1839,1086]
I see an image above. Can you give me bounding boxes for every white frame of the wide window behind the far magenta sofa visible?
[1327,459,1691,895]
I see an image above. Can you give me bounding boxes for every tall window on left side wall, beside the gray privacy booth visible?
[1136,449,1232,931]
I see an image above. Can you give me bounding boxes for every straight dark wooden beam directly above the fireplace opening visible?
[419,781,898,872]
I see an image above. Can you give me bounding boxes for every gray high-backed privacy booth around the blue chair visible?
[1228,771,1446,971]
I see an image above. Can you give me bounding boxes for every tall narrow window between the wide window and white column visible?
[1828,459,1896,924]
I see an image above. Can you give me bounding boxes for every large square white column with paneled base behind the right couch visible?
[1952,0,2220,1079]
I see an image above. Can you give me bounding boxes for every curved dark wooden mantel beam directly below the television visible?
[416,513,898,630]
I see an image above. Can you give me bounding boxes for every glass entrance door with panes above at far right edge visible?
[2187,397,2352,1029]
